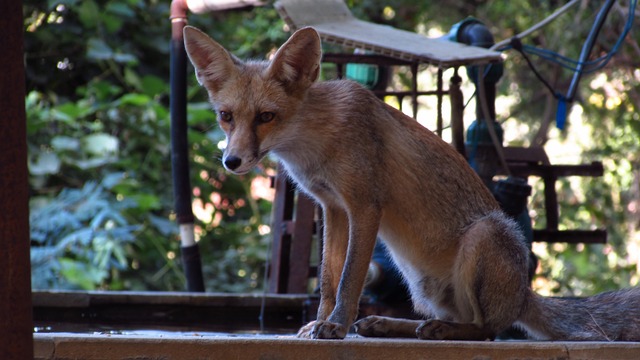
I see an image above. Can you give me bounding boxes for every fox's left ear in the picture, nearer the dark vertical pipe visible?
[183,26,242,91]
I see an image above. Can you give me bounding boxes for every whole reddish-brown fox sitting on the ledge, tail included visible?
[183,26,640,341]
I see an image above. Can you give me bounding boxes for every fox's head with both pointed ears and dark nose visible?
[184,26,322,174]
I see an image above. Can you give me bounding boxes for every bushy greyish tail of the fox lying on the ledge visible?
[515,288,640,341]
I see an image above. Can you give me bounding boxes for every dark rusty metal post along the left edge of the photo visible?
[0,1,33,359]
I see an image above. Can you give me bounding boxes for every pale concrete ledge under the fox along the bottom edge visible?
[34,333,640,360]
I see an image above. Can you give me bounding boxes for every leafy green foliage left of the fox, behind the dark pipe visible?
[24,0,286,291]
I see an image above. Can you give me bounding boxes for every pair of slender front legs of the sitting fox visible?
[298,204,380,339]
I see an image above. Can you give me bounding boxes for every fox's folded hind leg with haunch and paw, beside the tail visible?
[417,212,528,341]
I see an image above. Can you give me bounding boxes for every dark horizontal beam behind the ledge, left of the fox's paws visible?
[32,291,316,334]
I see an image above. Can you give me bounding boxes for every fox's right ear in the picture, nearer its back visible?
[267,27,322,93]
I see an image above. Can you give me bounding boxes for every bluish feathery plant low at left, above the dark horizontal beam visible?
[29,180,141,290]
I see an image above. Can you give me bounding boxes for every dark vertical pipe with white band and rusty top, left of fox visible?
[170,0,204,292]
